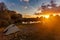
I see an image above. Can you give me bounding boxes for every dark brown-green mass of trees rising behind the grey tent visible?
[0,3,22,27]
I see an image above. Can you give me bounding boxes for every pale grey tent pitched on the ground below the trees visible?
[4,24,20,35]
